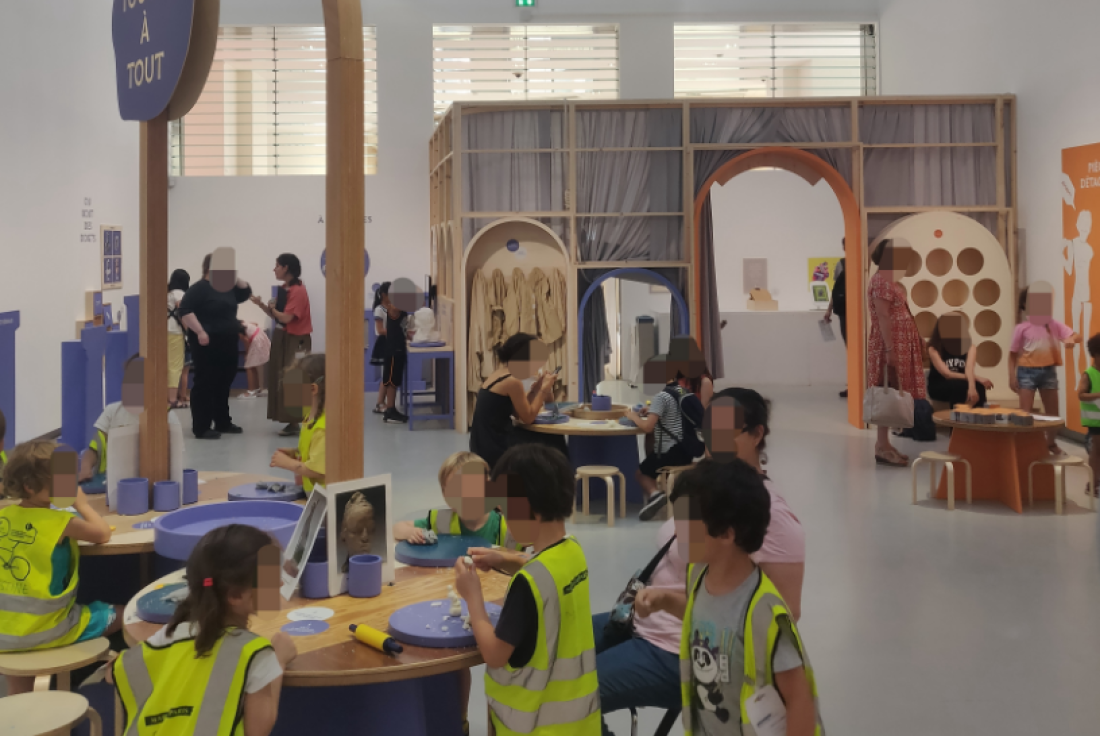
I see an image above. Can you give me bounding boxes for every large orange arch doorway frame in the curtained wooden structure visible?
[692,146,866,428]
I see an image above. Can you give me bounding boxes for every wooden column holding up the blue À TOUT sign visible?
[139,111,168,483]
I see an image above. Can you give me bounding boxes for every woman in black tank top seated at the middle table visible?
[470,332,558,468]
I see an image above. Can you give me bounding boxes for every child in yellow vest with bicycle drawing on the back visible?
[0,440,122,695]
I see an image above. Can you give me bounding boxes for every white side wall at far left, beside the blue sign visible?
[0,2,139,446]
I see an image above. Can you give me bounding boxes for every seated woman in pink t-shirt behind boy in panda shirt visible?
[592,388,806,734]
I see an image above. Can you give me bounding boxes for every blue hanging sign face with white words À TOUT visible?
[111,0,196,120]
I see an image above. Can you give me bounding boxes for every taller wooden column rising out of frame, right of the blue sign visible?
[323,0,365,483]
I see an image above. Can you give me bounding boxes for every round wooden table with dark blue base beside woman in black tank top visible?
[517,417,646,504]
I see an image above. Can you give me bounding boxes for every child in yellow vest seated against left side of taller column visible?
[271,353,325,493]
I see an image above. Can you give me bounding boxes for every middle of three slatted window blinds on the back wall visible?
[433,25,618,119]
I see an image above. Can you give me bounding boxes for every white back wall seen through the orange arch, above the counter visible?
[711,169,844,312]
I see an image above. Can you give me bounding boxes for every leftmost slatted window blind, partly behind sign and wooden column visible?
[171,25,378,176]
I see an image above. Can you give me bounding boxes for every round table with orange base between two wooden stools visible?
[932,410,1066,514]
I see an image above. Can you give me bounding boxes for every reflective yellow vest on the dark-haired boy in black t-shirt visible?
[485,537,601,736]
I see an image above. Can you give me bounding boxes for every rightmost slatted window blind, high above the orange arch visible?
[674,23,878,97]
